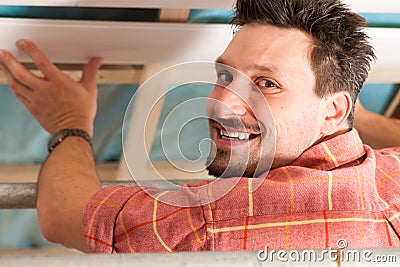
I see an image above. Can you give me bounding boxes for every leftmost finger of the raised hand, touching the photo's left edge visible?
[0,49,42,89]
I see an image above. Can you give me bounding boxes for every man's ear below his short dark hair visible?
[321,91,353,136]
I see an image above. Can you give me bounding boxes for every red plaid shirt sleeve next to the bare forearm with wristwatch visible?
[82,186,206,253]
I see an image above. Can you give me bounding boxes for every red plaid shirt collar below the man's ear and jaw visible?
[291,129,365,171]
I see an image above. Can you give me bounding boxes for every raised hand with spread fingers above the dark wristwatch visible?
[0,40,102,136]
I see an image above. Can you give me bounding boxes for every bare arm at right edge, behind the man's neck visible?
[354,101,400,149]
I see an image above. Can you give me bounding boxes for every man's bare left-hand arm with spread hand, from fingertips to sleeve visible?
[0,40,101,251]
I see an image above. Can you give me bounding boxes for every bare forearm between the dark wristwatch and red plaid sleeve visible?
[37,136,100,251]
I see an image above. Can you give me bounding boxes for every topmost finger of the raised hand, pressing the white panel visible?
[17,39,61,80]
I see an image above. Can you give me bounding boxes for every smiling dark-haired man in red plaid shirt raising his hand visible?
[0,0,400,253]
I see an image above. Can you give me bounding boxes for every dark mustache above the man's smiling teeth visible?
[209,116,266,133]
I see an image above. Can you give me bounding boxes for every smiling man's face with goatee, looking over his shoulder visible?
[207,25,326,177]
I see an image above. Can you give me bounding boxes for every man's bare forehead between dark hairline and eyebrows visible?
[219,25,313,71]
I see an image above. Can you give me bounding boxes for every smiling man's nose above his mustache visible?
[214,88,246,118]
